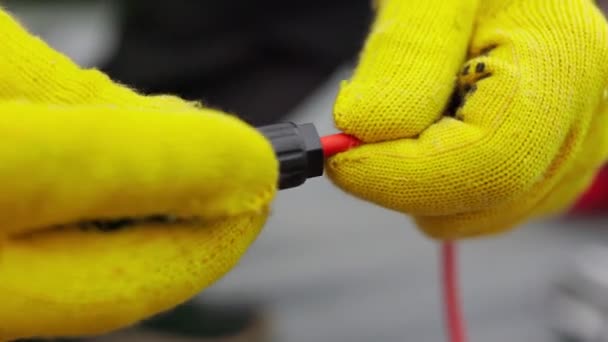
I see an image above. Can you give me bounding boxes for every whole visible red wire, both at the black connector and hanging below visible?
[321,133,467,342]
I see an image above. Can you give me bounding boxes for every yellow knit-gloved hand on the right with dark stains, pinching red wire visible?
[328,0,608,239]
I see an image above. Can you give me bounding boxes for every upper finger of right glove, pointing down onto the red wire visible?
[334,0,478,142]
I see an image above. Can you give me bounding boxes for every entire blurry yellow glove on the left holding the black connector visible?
[0,11,278,341]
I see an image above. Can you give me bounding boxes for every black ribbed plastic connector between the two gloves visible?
[258,122,324,190]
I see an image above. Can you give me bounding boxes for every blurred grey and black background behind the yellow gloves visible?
[7,0,608,342]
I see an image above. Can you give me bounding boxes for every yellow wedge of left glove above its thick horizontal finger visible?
[0,8,194,110]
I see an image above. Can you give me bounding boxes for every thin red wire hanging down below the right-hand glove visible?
[441,242,467,342]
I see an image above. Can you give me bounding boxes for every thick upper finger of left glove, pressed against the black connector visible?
[0,103,278,239]
